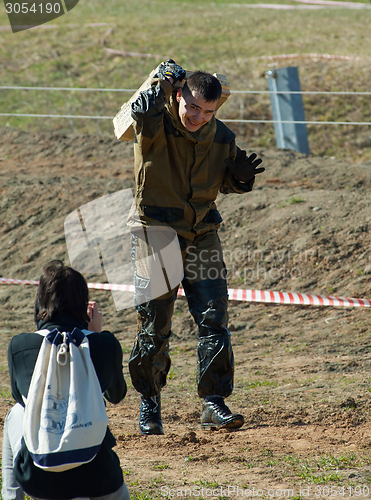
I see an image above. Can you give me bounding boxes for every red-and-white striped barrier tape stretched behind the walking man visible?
[0,278,371,307]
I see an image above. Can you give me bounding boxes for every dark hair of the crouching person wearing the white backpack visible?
[34,260,90,324]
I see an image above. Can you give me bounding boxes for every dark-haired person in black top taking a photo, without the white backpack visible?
[2,260,130,500]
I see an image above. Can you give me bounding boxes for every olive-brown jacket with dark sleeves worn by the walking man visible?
[129,79,254,240]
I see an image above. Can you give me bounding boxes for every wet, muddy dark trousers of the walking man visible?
[129,231,234,398]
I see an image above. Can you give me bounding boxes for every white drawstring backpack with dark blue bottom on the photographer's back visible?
[23,328,108,472]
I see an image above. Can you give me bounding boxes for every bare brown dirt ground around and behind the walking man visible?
[0,128,371,499]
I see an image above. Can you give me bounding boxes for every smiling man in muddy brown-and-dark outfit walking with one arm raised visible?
[129,60,264,434]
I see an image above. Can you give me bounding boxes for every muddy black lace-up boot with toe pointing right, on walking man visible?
[201,396,244,430]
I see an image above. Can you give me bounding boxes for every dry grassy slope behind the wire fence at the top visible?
[0,0,371,160]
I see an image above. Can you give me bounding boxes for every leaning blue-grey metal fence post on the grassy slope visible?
[266,67,310,154]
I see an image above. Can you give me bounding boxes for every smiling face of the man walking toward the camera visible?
[176,89,218,132]
